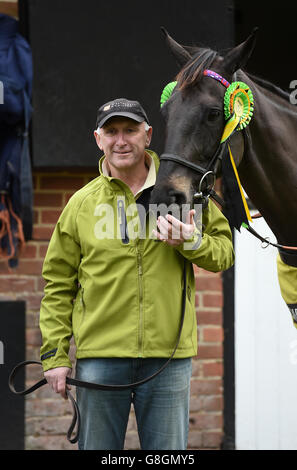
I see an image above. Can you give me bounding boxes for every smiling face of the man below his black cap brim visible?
[95,116,152,171]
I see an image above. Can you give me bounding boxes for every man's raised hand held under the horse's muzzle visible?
[153,209,196,246]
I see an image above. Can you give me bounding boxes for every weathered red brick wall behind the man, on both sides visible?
[0,171,223,449]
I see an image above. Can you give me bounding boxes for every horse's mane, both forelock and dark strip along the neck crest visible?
[176,46,290,101]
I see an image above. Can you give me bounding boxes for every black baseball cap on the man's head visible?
[96,98,149,128]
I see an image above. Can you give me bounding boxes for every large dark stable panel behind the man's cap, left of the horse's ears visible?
[20,0,233,168]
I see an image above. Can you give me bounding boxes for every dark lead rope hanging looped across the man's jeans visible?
[8,258,188,444]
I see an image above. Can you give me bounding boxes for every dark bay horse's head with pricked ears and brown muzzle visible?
[151,30,256,211]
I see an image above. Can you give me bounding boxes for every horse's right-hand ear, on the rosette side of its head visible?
[224,28,258,74]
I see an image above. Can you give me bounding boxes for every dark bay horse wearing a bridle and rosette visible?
[152,30,297,324]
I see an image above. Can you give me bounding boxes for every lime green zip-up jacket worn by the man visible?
[40,151,234,371]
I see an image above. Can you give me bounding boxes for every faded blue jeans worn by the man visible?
[76,358,192,450]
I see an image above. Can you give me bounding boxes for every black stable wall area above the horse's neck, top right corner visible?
[234,0,297,92]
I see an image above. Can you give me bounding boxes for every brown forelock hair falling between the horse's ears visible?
[176,48,218,90]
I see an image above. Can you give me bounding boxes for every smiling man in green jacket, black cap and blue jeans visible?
[40,98,234,450]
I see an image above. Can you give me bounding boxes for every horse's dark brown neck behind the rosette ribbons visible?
[237,72,297,245]
